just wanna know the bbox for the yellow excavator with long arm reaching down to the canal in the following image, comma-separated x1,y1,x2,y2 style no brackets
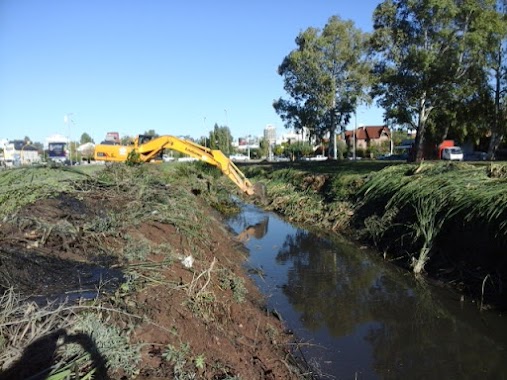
94,134,261,195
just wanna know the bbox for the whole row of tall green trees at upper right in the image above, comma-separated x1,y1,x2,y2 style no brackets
273,0,507,161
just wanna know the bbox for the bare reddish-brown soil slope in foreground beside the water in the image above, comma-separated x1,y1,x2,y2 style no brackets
130,223,302,379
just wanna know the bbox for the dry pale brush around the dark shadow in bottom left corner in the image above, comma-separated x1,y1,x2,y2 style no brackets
0,289,140,380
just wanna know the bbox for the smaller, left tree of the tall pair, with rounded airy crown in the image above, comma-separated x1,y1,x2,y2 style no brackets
273,16,370,159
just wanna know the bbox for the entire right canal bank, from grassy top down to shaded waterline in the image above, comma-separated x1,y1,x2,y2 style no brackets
247,162,507,308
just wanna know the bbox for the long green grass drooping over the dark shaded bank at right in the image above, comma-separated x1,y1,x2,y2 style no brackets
360,162,507,273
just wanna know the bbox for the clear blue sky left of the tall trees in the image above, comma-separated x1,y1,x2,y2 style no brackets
0,0,382,142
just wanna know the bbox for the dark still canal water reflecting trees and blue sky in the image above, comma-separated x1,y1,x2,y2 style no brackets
229,205,507,379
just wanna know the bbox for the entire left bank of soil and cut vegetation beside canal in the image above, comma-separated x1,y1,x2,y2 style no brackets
0,164,300,380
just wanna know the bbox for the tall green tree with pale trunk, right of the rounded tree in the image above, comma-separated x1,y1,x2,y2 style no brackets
372,0,498,161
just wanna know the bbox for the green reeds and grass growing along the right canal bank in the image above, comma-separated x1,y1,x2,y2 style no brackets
249,162,507,280
